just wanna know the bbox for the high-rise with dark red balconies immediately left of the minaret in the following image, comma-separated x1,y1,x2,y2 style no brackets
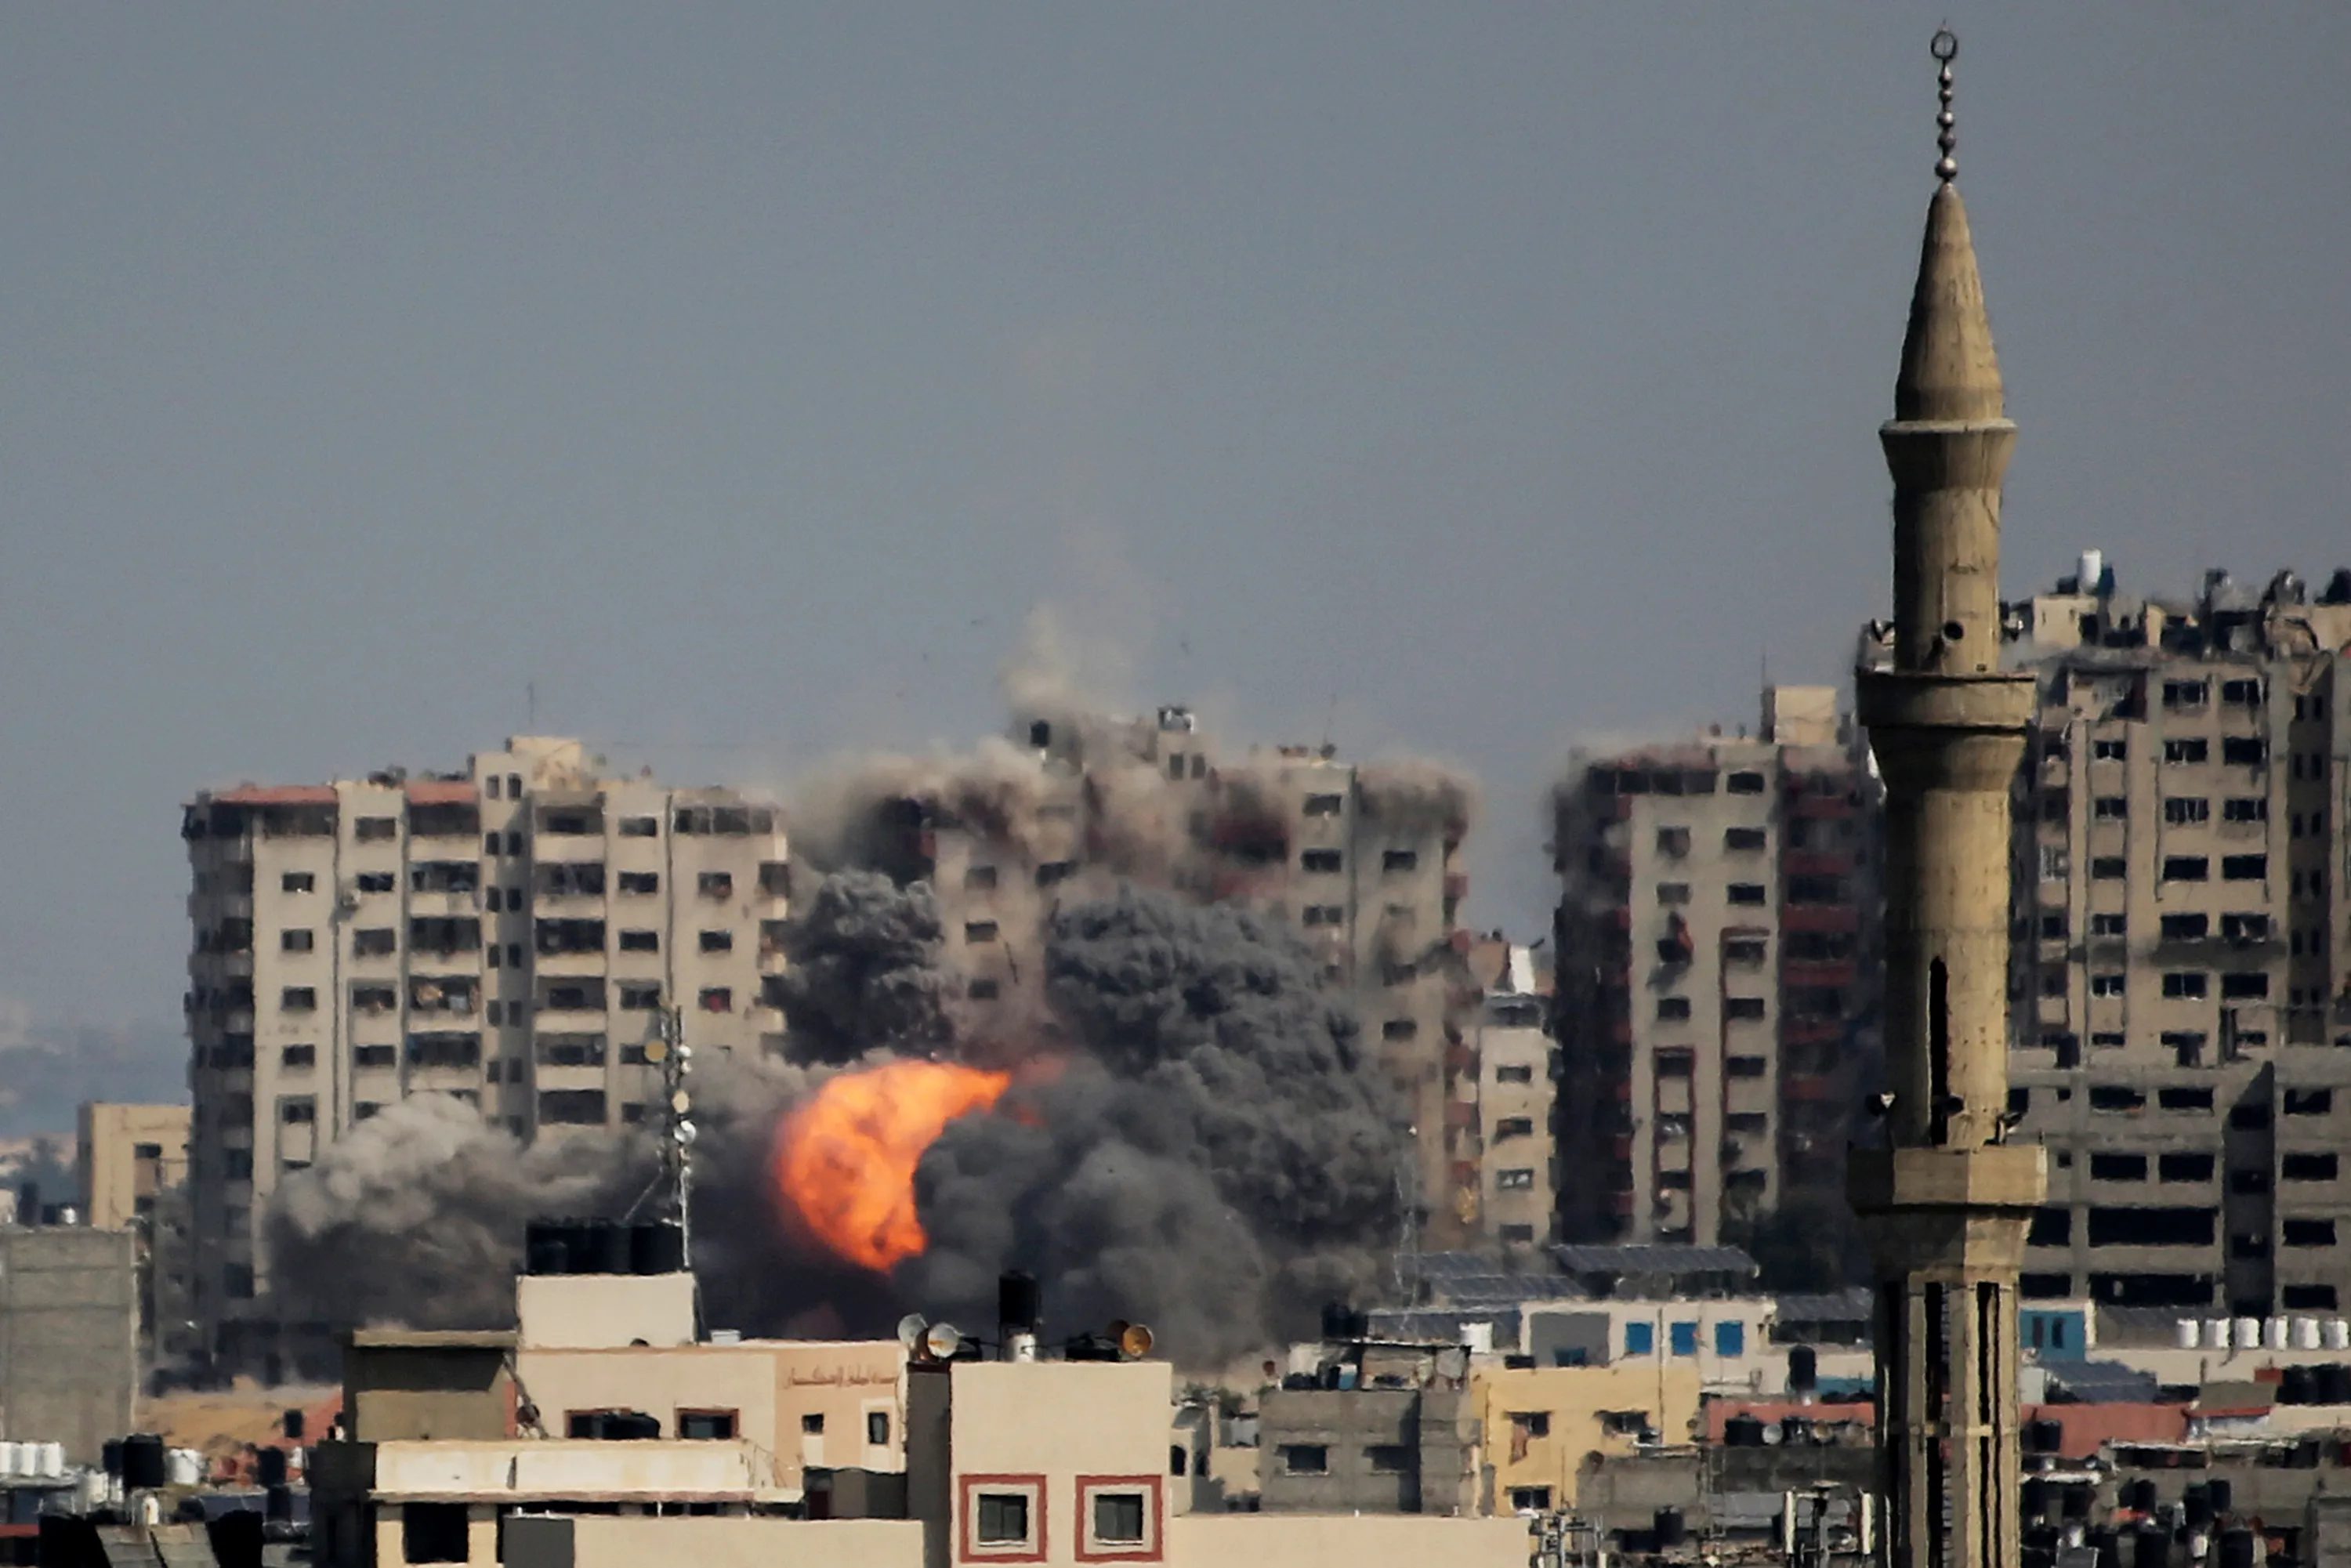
1552,686,1878,1246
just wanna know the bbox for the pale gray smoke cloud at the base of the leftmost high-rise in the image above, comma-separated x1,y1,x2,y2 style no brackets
268,1093,656,1328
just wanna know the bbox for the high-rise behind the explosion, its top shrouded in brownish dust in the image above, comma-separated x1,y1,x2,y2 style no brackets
856,708,1481,1248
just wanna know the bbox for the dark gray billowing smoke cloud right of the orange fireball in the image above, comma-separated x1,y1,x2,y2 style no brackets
900,889,1406,1366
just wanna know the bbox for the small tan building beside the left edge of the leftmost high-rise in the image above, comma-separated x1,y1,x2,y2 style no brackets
75,1100,195,1366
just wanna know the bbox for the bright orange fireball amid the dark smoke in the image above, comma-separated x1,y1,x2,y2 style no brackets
776,1060,1013,1274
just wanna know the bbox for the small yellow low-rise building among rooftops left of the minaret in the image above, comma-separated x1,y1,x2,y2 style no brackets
1469,1356,1700,1514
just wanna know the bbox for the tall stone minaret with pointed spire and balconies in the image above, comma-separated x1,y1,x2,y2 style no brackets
1848,33,2048,1568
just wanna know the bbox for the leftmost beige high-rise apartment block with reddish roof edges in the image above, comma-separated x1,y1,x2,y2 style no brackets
181,736,790,1363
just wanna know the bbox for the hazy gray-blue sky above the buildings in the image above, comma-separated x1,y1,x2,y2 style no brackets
0,0,2351,1063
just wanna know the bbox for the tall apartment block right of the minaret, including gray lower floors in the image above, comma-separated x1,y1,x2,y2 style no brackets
2008,552,2351,1314
